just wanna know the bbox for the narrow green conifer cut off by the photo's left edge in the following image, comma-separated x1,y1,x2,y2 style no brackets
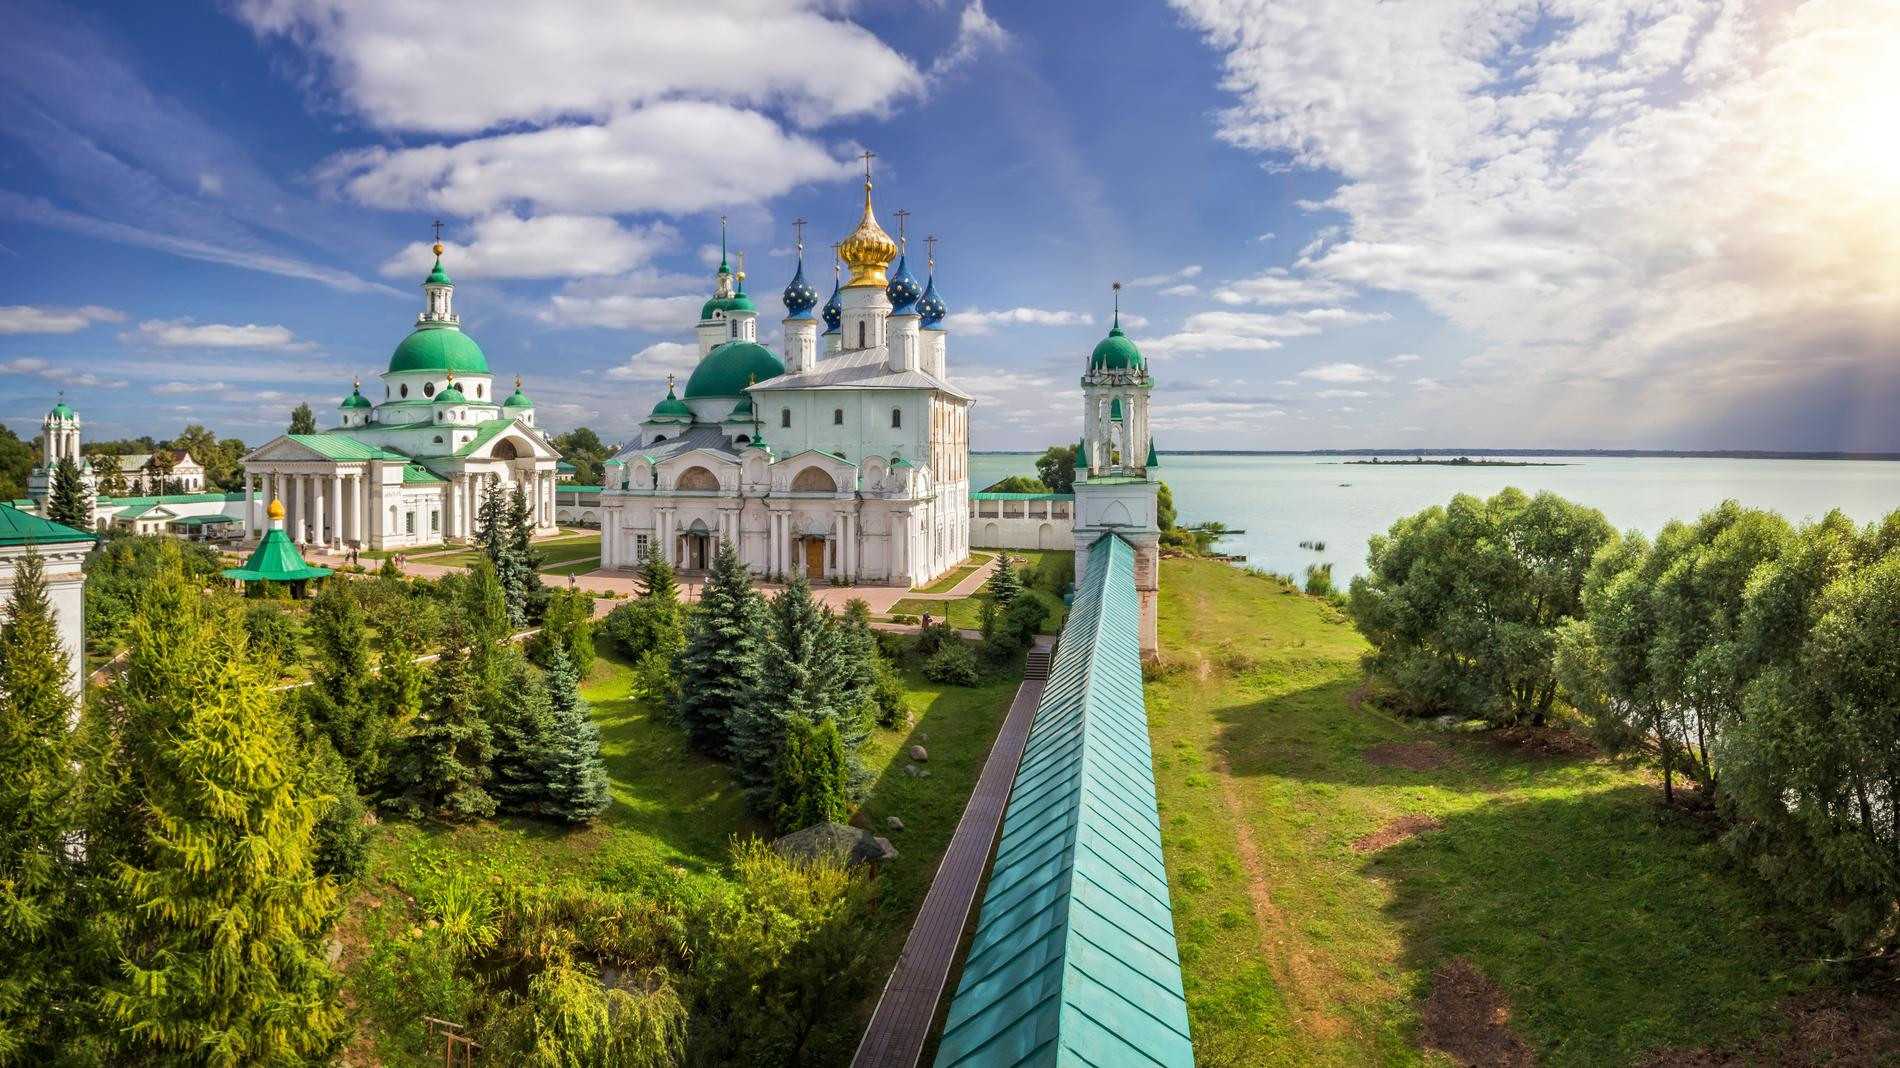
0,551,76,1064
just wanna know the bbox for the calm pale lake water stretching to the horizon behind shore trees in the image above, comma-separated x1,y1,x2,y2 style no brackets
969,452,1900,585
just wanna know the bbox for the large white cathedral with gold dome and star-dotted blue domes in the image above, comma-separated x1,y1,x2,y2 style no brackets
600,175,971,585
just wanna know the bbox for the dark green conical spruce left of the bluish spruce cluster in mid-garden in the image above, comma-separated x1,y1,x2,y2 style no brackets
410,620,496,819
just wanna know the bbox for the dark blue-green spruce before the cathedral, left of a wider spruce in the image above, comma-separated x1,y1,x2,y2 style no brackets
673,542,766,756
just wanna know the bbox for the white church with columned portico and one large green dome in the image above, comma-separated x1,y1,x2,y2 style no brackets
243,243,559,549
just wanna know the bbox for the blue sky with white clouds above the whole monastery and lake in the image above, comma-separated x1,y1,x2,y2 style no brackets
0,0,1900,450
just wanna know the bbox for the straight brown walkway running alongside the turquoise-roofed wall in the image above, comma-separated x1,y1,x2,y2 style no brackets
851,639,1049,1068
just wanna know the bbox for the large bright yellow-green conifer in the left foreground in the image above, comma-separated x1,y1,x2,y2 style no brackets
87,549,346,1064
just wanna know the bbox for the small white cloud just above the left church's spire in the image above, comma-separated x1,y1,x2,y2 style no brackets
382,213,678,277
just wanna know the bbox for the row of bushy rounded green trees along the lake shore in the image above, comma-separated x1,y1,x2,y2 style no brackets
1347,490,1900,952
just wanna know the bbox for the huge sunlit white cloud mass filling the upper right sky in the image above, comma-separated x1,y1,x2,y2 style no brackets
1174,0,1900,448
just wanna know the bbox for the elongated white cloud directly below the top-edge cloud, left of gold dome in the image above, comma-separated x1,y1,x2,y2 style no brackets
319,101,857,215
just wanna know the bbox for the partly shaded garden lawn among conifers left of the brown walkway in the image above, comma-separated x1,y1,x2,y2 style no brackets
342,630,1017,1066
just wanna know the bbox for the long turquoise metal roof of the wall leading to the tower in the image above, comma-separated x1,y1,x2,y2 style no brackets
937,534,1193,1068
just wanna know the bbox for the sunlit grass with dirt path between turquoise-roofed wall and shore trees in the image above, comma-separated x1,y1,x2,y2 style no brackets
1148,561,1813,1068
